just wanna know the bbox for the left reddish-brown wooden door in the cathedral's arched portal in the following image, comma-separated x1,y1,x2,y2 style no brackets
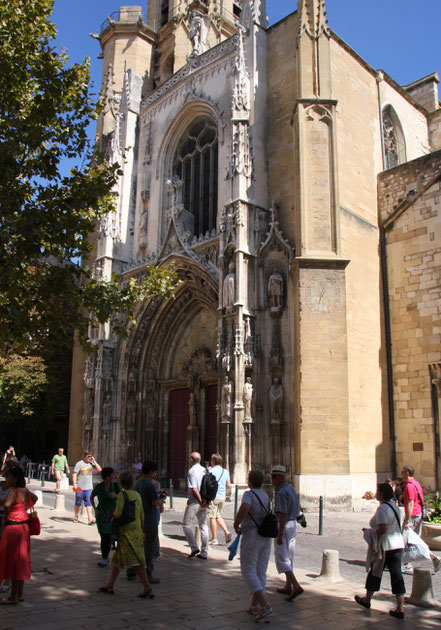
168,389,190,484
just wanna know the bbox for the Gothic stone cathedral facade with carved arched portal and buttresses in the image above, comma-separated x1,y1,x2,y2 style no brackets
69,0,441,504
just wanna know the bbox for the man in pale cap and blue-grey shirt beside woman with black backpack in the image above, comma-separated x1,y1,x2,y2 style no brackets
271,466,303,601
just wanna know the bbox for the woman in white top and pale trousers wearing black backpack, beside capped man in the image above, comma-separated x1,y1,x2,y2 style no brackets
234,470,273,621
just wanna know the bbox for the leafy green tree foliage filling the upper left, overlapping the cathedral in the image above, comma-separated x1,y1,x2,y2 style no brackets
0,0,174,352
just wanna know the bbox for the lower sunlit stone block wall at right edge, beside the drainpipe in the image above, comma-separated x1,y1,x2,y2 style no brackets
378,151,441,490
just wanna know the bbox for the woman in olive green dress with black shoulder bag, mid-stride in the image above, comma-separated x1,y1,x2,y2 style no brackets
100,470,154,599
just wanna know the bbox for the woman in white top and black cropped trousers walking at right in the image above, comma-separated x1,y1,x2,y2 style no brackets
355,483,406,619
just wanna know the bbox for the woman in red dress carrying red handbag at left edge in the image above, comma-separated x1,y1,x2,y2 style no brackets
0,464,38,606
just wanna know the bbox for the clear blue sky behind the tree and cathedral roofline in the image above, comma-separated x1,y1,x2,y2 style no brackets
53,0,441,95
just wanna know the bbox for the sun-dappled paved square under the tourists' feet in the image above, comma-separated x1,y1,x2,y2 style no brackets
0,484,441,630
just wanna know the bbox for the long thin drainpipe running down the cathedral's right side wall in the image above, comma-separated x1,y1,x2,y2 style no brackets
376,70,397,476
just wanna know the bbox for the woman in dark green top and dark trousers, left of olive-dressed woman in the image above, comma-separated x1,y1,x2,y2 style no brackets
90,466,121,567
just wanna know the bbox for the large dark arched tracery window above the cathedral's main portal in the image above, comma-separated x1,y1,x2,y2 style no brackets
173,116,218,236
